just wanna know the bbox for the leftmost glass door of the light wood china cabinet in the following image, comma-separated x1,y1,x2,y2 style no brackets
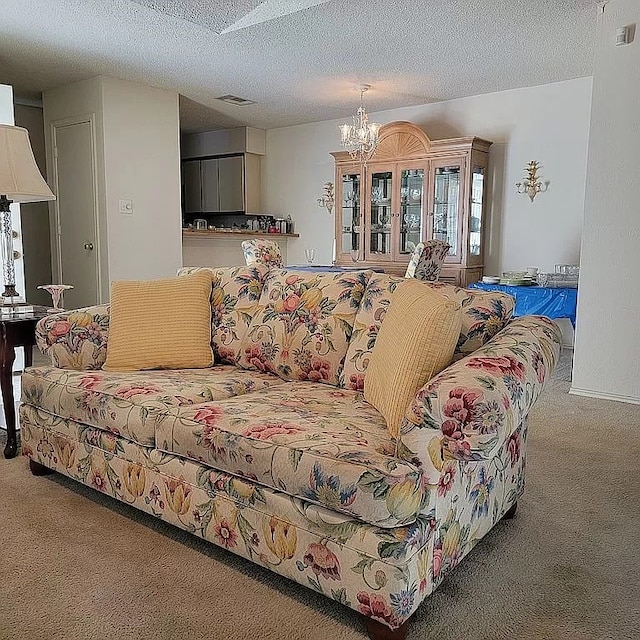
335,166,363,261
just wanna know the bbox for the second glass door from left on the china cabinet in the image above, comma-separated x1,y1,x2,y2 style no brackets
365,165,396,262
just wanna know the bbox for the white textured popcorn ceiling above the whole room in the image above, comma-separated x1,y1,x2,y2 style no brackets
0,0,599,130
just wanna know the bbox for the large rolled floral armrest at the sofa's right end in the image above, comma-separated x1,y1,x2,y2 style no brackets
398,316,560,469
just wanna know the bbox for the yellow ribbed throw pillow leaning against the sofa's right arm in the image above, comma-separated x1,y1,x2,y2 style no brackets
364,279,462,438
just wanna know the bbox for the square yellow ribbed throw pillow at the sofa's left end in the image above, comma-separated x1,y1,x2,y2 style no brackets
102,271,213,371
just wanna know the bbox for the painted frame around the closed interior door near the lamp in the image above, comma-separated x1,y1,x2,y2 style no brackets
49,113,103,304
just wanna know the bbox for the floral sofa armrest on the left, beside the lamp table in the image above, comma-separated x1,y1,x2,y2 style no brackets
36,305,109,371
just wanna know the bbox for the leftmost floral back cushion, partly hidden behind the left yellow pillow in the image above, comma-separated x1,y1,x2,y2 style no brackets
178,264,269,364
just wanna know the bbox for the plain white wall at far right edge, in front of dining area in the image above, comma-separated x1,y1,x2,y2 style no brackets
572,0,640,403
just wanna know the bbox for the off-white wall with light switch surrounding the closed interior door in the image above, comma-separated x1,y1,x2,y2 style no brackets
43,76,182,301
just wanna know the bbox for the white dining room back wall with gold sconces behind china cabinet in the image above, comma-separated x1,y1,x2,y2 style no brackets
263,78,591,274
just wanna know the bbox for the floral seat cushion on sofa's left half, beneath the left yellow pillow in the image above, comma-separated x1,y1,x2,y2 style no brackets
22,366,283,447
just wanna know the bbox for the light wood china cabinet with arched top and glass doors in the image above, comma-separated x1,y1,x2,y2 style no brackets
331,122,491,286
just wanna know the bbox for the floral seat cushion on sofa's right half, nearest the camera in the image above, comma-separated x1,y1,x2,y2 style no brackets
156,382,428,527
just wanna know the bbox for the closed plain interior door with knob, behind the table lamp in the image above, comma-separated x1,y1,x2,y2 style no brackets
52,120,99,309
